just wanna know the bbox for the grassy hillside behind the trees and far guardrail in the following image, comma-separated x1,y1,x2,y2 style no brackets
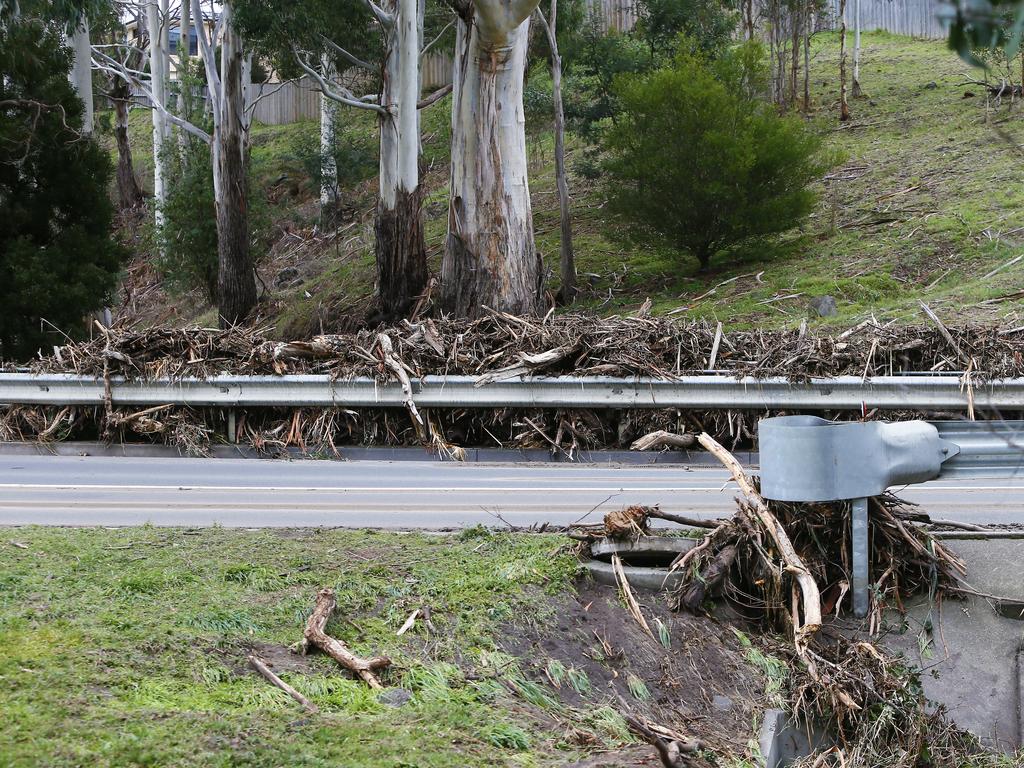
108,33,1024,336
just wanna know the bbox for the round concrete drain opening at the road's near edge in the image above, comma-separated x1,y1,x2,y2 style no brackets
586,536,698,592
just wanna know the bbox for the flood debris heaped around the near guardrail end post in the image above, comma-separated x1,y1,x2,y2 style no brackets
585,434,1005,768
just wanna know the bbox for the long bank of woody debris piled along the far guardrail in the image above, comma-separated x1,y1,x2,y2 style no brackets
0,311,1024,458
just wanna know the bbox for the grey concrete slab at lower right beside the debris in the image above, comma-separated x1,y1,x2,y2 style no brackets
883,540,1024,750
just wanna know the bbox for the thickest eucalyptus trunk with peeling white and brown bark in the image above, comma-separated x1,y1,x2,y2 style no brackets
441,0,541,316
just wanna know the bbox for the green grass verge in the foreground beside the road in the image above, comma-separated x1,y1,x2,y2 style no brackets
0,527,598,768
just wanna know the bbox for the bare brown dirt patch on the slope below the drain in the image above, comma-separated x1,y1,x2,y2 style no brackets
505,579,765,753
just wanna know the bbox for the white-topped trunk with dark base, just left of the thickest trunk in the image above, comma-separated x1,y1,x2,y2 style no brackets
376,0,427,315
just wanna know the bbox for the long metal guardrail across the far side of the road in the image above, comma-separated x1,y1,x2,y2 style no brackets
0,374,1024,412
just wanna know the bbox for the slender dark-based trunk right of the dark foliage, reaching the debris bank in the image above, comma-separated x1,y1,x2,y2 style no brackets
213,9,256,327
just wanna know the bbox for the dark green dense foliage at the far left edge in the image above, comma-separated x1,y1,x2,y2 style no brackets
0,17,124,357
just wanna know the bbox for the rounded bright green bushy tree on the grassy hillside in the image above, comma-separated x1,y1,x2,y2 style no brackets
604,43,827,270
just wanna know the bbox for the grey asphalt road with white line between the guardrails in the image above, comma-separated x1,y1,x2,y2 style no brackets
0,456,1024,528
